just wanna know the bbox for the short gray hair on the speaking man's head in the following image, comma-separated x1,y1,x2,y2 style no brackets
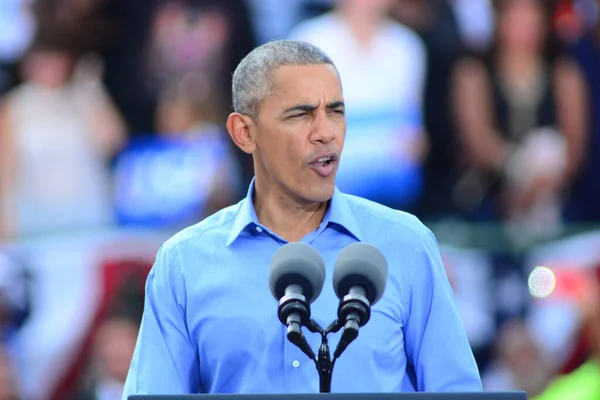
232,40,335,117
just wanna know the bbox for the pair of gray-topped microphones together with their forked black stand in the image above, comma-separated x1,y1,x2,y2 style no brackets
269,242,388,393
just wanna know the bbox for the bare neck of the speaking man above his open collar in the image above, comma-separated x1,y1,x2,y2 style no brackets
252,177,328,242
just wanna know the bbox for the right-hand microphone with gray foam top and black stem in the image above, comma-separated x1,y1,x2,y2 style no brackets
333,243,388,360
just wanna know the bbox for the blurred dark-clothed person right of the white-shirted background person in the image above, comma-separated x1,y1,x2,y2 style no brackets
392,0,465,221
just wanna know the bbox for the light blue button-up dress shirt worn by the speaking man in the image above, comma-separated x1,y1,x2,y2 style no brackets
123,184,481,399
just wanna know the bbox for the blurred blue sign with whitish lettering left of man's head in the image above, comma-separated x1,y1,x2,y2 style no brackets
115,128,238,226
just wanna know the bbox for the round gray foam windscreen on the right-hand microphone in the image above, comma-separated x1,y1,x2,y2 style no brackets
333,243,388,305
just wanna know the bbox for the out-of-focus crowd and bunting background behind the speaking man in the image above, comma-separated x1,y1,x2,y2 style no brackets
0,0,600,400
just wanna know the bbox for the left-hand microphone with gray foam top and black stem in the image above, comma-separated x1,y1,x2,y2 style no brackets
269,242,325,360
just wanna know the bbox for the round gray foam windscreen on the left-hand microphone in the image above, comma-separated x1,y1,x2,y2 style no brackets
269,242,325,304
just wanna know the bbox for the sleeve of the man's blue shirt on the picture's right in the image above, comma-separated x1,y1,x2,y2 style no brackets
405,229,482,392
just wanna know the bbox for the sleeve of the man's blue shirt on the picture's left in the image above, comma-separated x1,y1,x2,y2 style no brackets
122,242,200,400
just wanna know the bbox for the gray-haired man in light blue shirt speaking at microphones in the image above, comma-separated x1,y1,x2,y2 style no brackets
123,41,481,399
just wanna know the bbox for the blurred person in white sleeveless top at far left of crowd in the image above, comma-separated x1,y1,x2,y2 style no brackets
0,24,125,239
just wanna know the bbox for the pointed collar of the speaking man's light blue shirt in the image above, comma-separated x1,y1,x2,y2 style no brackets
225,178,363,246
